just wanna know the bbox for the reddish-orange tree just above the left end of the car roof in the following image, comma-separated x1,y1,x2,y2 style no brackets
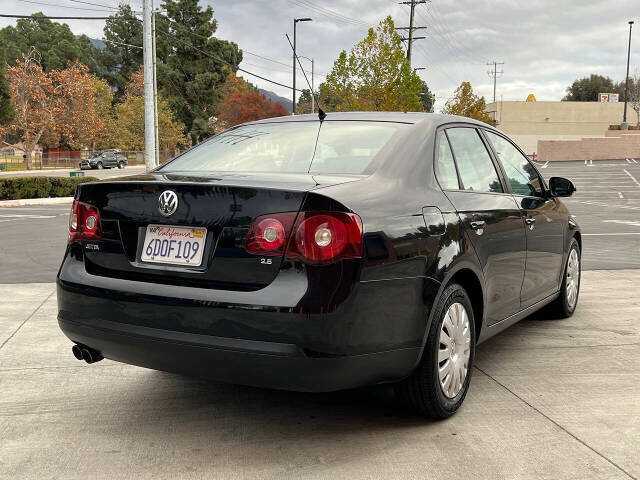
216,92,288,130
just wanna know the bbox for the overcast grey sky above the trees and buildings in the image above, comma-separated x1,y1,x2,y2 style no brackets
0,0,640,110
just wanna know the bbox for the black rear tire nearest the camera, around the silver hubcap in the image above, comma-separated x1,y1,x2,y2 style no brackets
395,283,476,419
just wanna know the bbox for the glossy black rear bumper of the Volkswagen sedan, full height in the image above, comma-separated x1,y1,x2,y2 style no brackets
58,254,439,391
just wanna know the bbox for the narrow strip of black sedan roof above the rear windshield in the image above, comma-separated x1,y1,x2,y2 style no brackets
246,112,490,127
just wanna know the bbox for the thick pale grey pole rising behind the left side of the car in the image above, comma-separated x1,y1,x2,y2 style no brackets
142,0,156,171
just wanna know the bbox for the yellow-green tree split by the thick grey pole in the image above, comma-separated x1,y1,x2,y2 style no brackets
105,68,186,150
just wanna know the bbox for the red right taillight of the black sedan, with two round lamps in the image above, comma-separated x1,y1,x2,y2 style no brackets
246,212,362,264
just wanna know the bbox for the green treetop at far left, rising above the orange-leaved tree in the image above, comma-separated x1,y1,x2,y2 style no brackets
0,13,100,72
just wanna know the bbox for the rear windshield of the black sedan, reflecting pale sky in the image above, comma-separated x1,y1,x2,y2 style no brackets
160,121,406,174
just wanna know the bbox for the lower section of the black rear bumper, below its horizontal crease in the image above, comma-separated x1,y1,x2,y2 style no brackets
58,318,420,392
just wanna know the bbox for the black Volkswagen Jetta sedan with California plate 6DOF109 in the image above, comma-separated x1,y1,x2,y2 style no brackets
57,113,582,418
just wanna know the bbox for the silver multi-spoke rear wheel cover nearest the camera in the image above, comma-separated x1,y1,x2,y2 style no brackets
438,303,471,398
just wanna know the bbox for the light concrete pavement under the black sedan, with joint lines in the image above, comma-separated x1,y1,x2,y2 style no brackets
0,270,640,480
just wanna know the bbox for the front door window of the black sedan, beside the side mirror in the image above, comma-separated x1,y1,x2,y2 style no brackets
485,131,543,197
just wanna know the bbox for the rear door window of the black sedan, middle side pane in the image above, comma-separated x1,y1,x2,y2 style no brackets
447,127,503,193
